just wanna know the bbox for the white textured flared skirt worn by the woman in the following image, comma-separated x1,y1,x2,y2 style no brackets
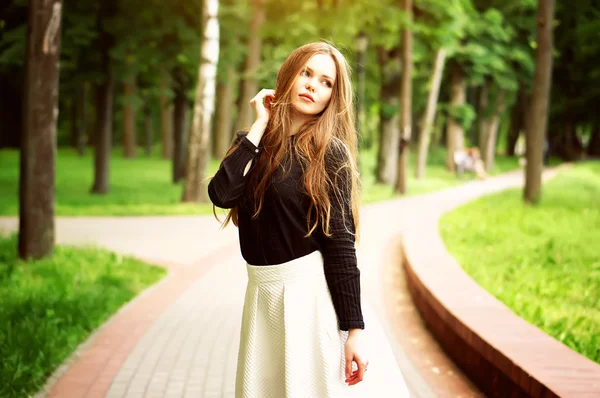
235,251,409,398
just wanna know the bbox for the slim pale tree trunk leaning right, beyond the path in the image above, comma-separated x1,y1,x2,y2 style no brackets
415,48,446,179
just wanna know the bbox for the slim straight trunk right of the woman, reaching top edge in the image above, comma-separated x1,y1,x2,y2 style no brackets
396,0,413,194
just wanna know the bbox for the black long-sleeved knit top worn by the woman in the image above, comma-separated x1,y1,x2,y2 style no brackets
208,132,364,330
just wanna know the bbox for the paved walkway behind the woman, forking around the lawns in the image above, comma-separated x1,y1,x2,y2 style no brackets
0,166,564,398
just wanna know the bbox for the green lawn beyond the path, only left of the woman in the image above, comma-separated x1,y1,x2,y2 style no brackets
0,148,223,216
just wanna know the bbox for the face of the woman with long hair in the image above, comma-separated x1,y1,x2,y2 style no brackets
291,54,336,116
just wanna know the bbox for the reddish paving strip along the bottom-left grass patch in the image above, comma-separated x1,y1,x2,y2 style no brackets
39,242,238,398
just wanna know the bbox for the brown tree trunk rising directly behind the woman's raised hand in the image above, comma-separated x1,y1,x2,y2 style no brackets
236,0,265,130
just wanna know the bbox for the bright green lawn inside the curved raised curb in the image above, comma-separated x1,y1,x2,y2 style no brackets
440,162,600,363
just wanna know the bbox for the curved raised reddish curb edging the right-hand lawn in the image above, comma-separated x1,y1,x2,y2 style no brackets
403,211,600,398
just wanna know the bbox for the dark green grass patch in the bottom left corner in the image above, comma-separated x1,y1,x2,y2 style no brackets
0,235,165,398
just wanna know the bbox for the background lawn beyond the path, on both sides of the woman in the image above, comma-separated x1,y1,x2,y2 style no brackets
0,148,518,216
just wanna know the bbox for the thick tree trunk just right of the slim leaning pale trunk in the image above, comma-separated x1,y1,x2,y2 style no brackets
446,64,466,172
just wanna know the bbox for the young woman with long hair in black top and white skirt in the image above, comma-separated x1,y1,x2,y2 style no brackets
208,42,408,398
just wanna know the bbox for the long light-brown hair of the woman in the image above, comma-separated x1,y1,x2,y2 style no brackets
213,42,359,240
